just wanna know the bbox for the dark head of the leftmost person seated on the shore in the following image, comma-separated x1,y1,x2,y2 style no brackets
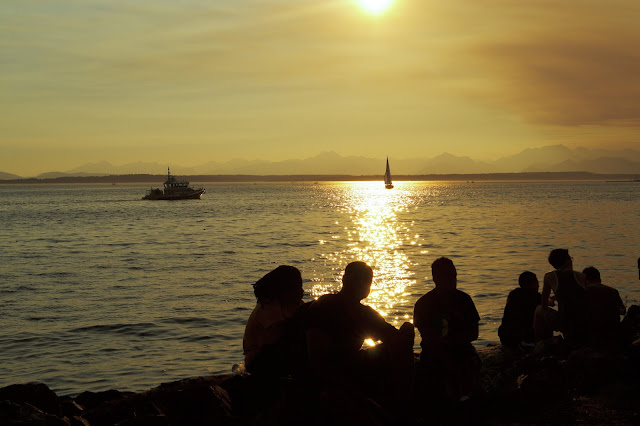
253,265,304,307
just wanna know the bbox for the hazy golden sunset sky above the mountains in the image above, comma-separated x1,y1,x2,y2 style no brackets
0,0,640,176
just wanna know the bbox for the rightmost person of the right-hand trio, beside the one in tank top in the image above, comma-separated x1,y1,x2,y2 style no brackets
582,266,627,347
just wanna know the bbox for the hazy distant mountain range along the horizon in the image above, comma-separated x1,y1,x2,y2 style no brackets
5,145,640,180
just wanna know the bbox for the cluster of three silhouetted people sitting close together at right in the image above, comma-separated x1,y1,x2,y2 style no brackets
498,249,626,351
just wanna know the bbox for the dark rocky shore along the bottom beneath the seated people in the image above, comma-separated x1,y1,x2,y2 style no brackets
5,306,640,426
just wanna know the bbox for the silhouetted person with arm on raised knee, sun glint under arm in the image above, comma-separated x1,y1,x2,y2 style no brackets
306,262,414,410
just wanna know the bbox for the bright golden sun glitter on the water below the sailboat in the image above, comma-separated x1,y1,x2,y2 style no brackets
312,182,420,325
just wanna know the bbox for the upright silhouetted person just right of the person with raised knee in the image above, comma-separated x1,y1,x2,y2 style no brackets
413,257,480,412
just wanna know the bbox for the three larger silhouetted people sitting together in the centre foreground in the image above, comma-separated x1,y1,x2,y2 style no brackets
243,257,480,422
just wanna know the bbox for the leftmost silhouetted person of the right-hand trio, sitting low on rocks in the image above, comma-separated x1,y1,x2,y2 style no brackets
498,271,542,350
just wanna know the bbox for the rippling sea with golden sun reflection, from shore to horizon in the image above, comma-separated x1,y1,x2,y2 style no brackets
0,182,640,395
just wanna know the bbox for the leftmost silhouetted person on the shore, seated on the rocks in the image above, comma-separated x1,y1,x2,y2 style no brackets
242,265,306,376
